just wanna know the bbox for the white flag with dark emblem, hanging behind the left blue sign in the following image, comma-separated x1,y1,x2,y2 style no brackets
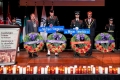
40,6,47,41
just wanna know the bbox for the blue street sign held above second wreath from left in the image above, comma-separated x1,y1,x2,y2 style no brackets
38,26,64,33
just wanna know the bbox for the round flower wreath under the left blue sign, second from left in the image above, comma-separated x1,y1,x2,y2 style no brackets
46,32,67,53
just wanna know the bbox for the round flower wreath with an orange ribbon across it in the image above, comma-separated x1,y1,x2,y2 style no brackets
71,34,91,54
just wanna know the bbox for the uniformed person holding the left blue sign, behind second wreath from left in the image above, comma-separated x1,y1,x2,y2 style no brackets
46,10,60,56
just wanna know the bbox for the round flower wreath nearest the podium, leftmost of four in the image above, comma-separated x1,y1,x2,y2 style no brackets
24,33,44,53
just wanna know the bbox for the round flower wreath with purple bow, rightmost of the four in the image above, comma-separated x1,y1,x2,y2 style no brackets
95,33,115,52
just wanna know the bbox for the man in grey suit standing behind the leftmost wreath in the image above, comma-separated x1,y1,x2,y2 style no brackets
25,13,38,58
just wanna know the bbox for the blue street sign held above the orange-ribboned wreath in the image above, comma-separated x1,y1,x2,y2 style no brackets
64,29,90,34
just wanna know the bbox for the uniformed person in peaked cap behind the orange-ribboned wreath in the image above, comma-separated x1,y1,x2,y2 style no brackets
70,11,83,57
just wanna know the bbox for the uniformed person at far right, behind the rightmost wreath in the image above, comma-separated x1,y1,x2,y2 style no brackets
105,18,115,52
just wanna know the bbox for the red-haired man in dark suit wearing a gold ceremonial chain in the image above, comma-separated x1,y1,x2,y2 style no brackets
85,11,96,56
